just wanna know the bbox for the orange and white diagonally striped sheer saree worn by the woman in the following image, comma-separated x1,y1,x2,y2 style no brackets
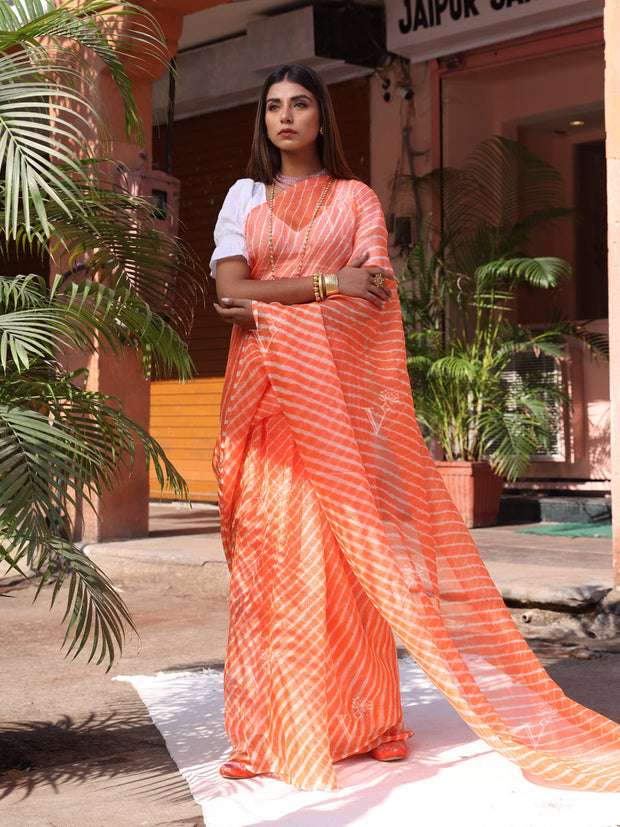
215,177,620,791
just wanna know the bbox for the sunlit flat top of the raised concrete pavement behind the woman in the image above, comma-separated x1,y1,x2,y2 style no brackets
85,503,613,600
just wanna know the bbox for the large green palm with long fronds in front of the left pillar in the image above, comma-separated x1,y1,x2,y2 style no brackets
0,0,204,665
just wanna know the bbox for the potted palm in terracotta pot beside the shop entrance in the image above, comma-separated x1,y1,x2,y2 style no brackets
400,137,606,527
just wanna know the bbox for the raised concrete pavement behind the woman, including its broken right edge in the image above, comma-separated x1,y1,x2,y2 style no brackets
86,503,620,640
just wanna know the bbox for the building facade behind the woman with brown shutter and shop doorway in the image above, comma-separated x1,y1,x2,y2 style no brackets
145,0,611,500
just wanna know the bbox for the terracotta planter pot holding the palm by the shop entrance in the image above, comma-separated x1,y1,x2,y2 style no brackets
437,462,504,528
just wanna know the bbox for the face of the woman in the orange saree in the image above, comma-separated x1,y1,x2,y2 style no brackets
265,80,321,159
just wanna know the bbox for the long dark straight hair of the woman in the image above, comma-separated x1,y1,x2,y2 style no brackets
246,63,357,184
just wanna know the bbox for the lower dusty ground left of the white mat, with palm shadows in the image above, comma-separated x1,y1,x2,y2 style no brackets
0,585,227,827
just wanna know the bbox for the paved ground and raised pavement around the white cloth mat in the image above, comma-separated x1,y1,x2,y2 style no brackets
0,506,620,827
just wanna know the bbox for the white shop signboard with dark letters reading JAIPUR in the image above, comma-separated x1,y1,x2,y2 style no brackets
385,0,604,63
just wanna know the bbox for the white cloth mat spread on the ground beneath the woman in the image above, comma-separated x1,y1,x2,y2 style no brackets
117,658,620,827
